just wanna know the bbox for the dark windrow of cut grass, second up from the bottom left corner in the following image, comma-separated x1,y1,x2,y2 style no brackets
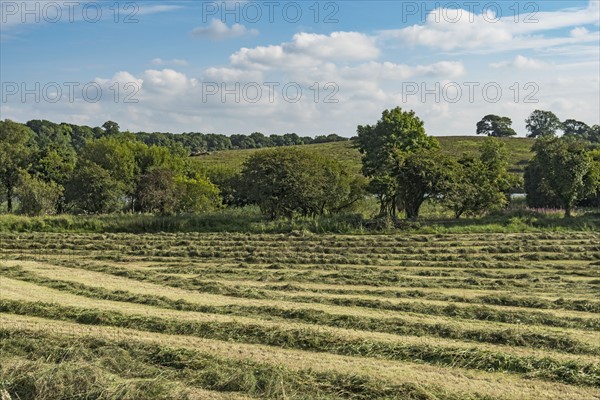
0,300,600,388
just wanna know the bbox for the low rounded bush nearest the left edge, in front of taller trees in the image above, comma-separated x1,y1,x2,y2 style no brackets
15,172,63,216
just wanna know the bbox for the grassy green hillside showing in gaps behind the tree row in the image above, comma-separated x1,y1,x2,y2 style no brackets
195,136,533,172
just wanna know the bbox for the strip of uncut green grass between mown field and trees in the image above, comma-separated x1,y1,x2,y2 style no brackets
0,205,600,235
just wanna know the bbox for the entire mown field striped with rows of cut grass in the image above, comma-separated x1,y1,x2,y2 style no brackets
0,231,600,400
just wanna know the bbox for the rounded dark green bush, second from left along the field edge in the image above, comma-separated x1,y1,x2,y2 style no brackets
65,159,125,214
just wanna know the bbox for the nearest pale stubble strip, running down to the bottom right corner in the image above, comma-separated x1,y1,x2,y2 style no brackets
0,314,597,400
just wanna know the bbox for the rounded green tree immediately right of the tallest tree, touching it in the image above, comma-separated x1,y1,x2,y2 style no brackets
394,149,454,220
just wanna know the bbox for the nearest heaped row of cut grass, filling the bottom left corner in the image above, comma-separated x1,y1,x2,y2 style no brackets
0,330,486,400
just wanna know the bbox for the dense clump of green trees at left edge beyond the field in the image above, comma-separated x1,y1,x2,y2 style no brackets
0,120,221,215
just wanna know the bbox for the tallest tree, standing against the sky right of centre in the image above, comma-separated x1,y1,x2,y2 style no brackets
356,107,439,217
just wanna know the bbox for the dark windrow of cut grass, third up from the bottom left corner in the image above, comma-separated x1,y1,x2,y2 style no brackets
0,267,600,355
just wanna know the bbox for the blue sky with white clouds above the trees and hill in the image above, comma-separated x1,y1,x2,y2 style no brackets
0,0,600,137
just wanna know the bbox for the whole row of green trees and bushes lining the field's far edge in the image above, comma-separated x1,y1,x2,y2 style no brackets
0,107,600,219
